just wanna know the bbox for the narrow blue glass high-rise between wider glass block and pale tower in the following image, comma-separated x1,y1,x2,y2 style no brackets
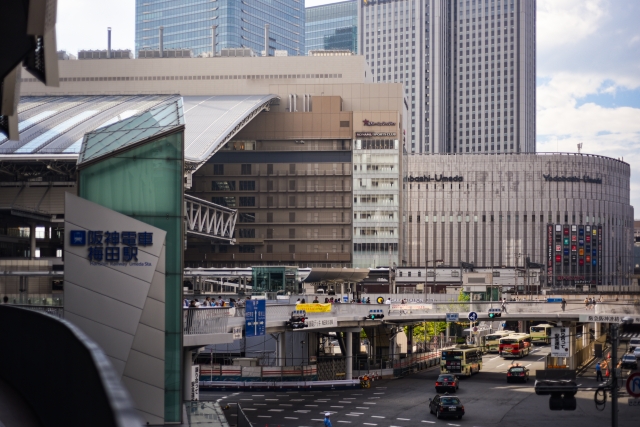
305,0,358,55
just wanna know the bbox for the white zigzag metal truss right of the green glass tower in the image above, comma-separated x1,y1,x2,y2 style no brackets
184,194,238,244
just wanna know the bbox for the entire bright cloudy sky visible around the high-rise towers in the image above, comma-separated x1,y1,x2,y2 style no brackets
57,0,640,214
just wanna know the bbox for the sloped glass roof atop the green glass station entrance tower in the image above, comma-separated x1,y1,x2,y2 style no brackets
78,97,184,165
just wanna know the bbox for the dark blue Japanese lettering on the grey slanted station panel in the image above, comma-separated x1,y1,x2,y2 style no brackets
69,230,153,267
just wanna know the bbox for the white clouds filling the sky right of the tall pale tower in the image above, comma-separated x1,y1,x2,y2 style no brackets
537,0,640,216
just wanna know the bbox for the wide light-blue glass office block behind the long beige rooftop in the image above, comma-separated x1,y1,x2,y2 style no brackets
136,0,305,56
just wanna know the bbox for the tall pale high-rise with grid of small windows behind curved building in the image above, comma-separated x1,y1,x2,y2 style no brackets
358,0,536,154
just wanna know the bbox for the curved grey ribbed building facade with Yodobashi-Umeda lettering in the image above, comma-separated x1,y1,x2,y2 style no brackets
403,153,633,290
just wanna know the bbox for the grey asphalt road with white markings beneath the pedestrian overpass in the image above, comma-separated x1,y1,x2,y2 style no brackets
205,346,640,427
